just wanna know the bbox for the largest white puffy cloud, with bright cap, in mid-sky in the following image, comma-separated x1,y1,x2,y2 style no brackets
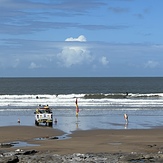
57,35,93,67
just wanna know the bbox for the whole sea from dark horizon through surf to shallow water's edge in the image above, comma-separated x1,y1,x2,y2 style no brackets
0,77,163,133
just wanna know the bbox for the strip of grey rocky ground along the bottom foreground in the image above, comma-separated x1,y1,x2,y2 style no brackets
0,149,163,163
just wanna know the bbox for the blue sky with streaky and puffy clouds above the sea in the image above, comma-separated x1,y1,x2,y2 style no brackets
0,0,163,77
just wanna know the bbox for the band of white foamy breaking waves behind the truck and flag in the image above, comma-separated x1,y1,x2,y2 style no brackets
0,93,163,111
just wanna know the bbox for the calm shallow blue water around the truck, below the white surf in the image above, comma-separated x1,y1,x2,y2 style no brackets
0,109,163,133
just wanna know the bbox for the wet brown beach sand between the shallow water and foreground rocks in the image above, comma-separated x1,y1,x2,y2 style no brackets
0,126,163,155
